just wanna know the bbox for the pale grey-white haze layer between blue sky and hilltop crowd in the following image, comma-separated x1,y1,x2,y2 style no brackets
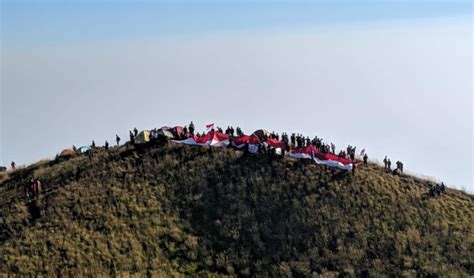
0,3,474,191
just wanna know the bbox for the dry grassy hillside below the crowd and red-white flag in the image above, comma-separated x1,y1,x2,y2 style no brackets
0,145,474,276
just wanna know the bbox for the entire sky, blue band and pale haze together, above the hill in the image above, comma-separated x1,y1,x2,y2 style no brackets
0,1,474,191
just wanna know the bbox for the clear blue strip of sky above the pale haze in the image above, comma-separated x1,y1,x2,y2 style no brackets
2,0,472,47
